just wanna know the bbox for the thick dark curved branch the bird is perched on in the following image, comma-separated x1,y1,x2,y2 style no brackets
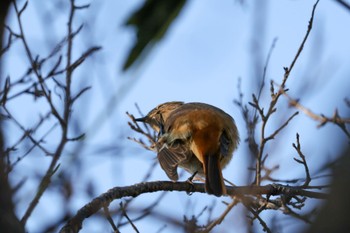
60,181,328,233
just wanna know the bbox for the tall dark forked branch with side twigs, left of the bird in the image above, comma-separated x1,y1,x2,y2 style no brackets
11,0,101,225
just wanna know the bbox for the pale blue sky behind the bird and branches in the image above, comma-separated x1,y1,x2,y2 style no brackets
3,0,350,232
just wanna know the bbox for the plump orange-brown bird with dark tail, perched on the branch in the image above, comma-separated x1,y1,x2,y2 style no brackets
136,101,240,196
